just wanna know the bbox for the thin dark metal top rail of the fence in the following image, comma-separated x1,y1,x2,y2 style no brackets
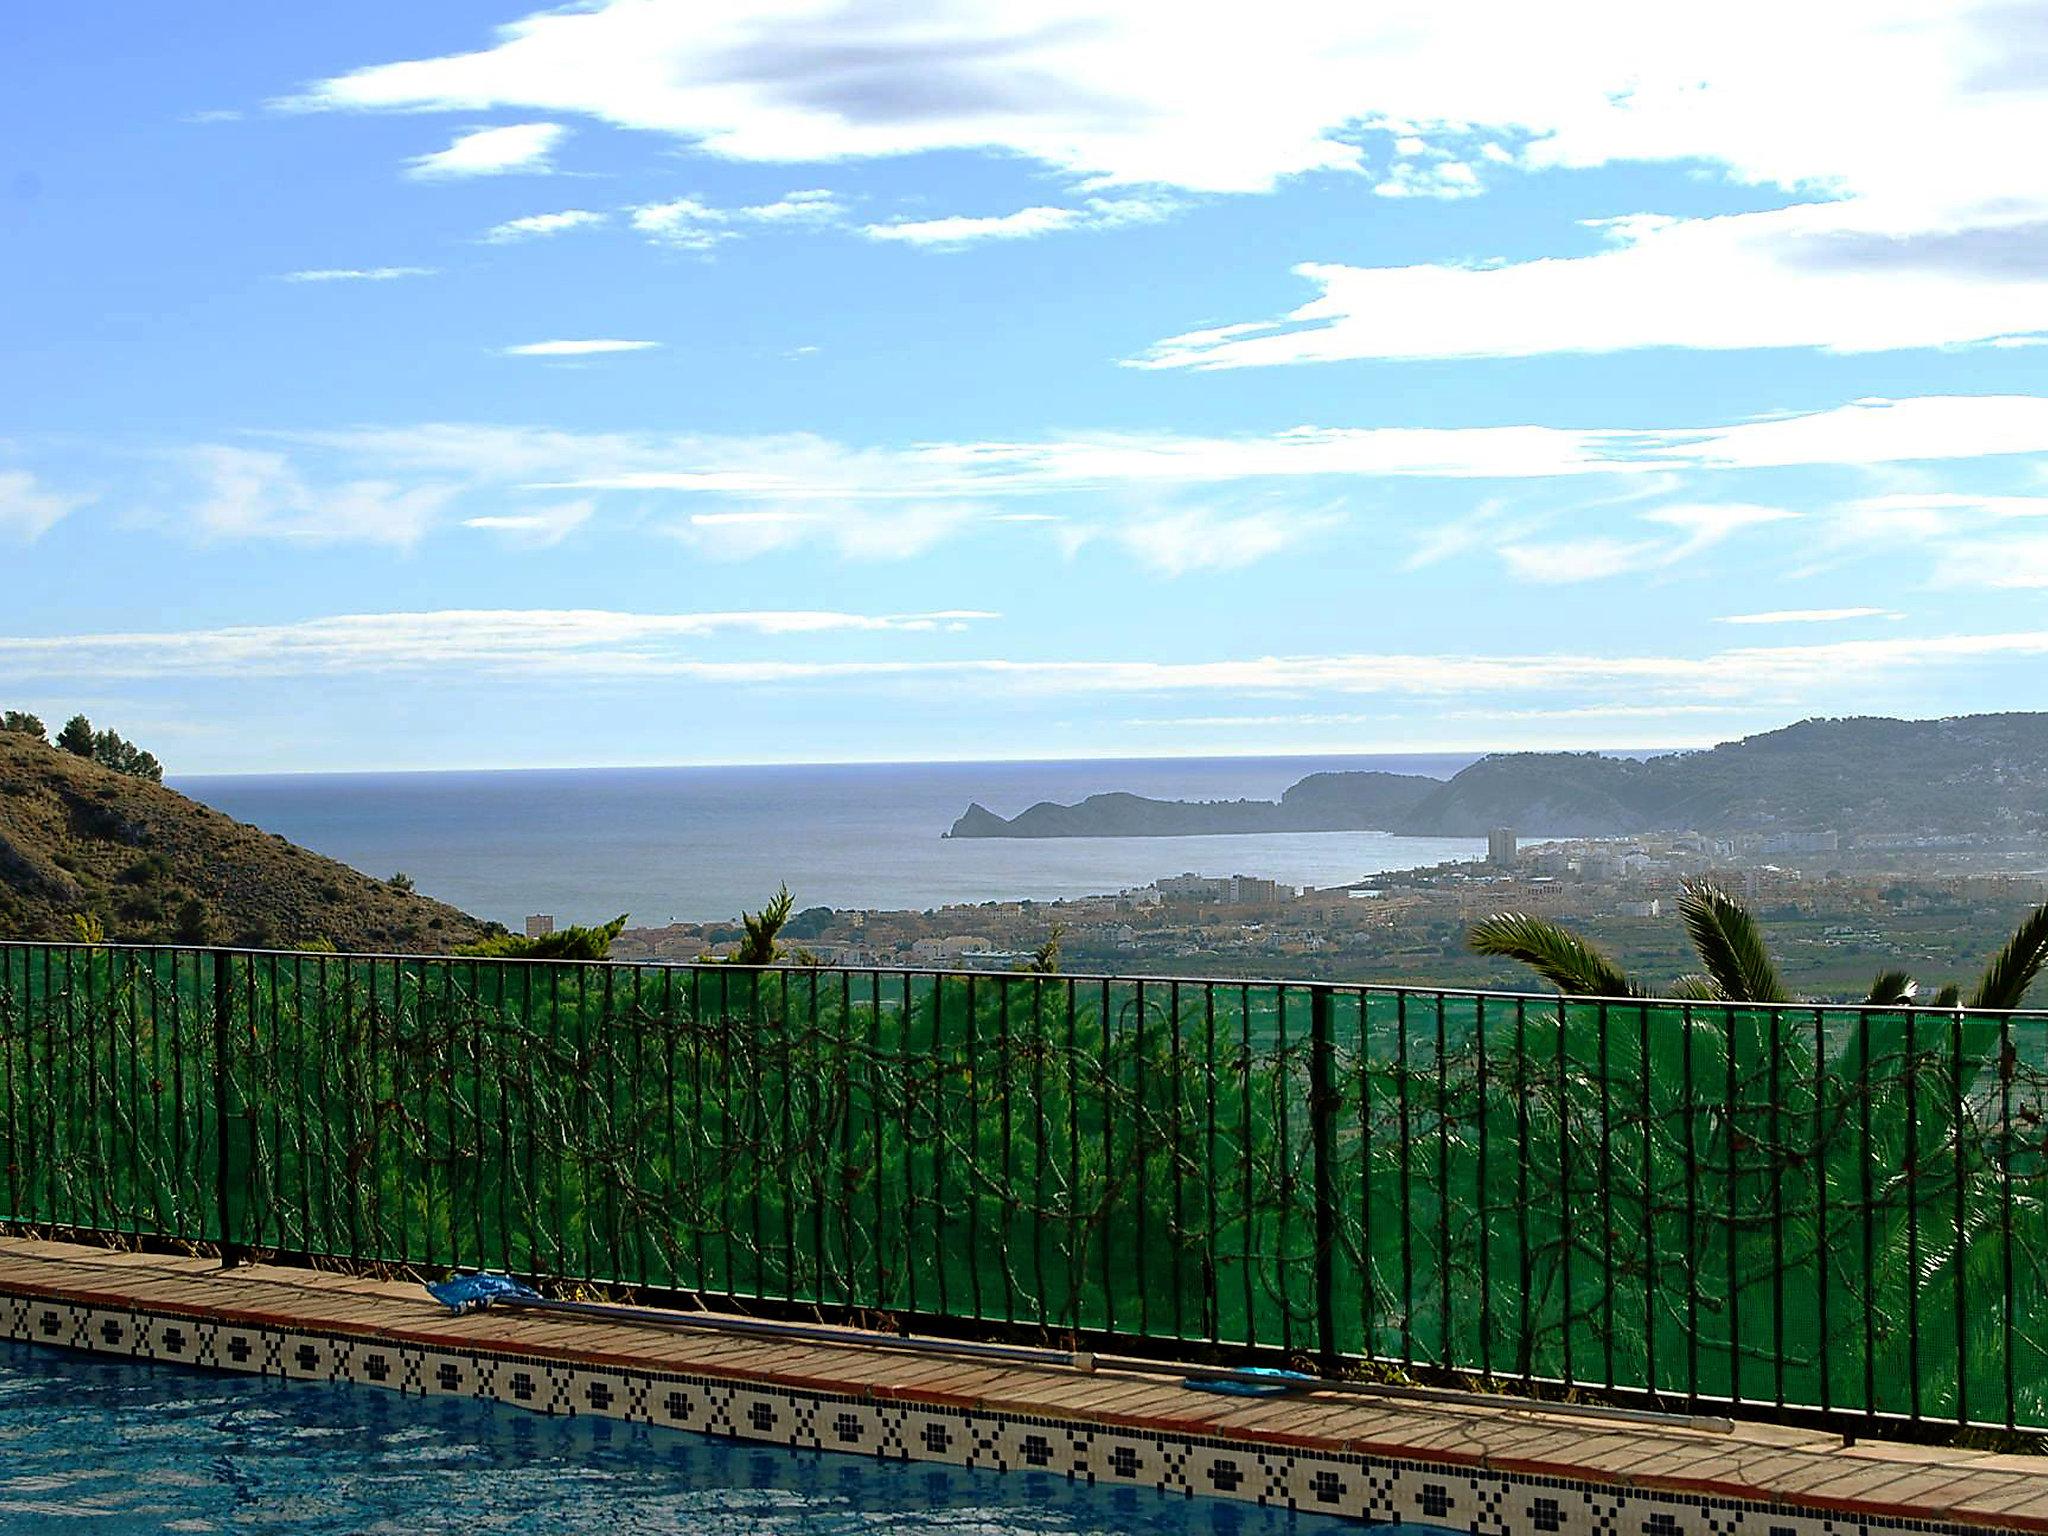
0,938,2048,1020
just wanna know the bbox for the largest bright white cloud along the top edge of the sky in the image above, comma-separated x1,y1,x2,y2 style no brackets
303,0,2042,197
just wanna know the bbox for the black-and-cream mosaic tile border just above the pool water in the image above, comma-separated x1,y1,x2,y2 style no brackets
0,1294,2015,1536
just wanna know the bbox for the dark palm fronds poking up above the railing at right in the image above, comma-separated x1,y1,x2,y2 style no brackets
1466,879,2048,1010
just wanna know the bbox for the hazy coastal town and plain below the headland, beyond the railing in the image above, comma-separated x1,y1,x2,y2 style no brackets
612,827,2048,993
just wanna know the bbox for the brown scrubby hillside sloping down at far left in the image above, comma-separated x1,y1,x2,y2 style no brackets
0,731,483,952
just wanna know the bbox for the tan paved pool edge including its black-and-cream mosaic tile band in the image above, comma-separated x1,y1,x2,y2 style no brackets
0,1239,2048,1536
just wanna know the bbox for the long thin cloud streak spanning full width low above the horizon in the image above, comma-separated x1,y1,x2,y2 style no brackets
12,610,2048,713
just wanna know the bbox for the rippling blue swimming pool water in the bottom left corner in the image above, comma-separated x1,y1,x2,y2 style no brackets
0,1343,1401,1536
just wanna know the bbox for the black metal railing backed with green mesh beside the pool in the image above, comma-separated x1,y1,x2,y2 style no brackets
0,944,2048,1430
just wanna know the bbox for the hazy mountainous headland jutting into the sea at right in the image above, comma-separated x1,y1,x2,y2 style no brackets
948,713,2048,838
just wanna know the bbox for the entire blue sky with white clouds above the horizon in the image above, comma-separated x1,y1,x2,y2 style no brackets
0,0,2048,776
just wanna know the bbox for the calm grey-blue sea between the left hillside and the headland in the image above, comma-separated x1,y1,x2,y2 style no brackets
170,754,1485,928
